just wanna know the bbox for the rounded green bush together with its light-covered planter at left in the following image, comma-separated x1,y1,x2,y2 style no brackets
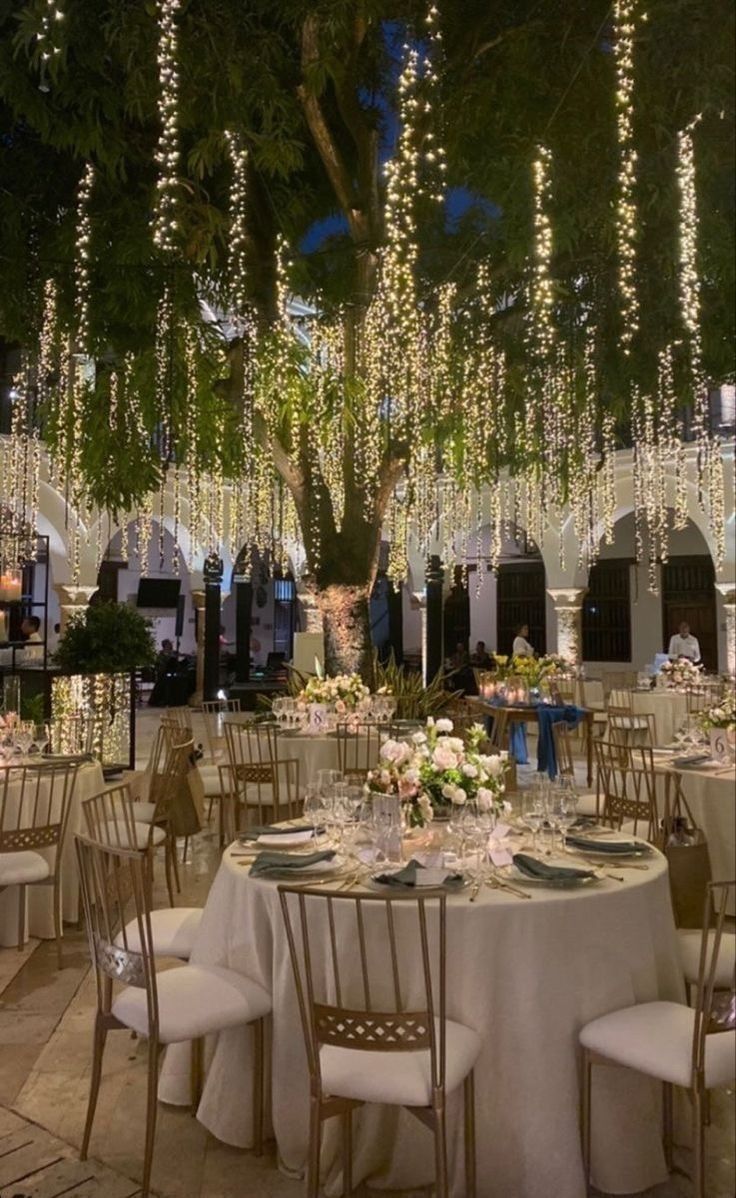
52,603,156,768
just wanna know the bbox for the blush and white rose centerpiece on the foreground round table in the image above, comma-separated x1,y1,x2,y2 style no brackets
368,718,509,828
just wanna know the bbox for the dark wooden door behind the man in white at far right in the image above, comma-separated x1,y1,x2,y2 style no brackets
662,553,718,670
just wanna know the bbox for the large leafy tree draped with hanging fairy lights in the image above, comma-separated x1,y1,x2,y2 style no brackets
0,0,734,670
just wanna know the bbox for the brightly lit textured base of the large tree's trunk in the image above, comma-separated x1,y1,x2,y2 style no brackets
313,583,373,686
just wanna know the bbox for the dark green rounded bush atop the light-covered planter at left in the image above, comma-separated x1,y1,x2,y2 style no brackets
54,603,156,673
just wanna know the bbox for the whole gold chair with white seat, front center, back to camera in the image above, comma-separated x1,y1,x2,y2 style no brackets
278,885,481,1198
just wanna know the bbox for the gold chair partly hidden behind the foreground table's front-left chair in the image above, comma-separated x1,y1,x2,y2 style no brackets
82,785,201,961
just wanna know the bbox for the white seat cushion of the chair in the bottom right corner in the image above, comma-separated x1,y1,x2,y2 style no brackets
580,1003,736,1089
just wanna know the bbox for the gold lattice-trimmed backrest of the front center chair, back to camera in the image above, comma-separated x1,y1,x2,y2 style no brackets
278,885,446,1089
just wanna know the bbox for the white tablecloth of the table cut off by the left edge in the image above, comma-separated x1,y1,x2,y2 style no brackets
0,761,105,946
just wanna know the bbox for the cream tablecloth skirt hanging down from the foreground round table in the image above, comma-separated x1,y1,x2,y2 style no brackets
159,846,684,1198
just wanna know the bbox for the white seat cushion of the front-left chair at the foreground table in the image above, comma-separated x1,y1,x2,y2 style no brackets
113,966,271,1045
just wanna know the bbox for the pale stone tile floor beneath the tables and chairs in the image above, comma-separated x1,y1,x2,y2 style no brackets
0,710,735,1198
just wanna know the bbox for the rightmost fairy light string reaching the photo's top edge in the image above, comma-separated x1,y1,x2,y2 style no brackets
614,0,639,353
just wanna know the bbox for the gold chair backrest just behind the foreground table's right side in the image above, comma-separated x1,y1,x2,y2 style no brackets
593,740,657,843
